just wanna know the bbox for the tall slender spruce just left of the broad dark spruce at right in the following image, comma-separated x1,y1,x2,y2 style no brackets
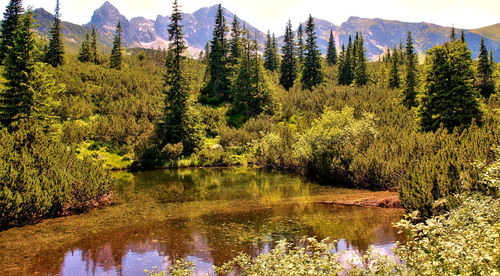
403,31,418,108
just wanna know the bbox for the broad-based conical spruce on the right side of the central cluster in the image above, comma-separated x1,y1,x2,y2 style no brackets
234,33,272,115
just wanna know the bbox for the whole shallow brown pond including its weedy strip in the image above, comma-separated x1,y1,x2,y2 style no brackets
0,168,402,275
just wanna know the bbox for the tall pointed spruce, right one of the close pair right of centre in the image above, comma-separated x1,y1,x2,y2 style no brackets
302,15,324,90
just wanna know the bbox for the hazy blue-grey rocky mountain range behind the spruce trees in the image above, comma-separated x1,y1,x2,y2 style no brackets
35,2,500,62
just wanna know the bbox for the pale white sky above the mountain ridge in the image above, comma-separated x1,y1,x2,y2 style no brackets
0,0,500,33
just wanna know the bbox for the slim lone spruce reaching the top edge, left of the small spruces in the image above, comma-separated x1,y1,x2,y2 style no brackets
45,0,64,67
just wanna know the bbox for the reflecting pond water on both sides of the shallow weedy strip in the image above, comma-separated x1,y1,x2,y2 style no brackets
1,169,401,275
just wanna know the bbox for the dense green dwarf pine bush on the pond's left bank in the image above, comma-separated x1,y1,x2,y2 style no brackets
0,121,112,227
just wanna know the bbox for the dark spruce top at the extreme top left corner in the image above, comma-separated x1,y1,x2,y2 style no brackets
0,0,24,64
